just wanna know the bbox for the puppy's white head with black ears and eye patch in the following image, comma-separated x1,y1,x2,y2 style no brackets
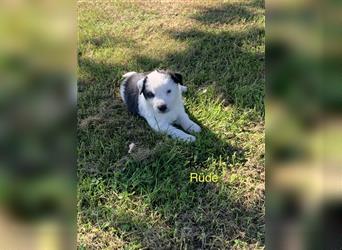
138,70,185,113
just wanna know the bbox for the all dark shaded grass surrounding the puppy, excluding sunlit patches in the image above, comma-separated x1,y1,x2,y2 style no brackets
78,2,264,249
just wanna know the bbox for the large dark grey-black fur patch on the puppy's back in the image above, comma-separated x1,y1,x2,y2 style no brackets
124,73,146,115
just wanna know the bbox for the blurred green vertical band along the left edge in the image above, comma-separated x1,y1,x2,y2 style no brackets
0,0,77,250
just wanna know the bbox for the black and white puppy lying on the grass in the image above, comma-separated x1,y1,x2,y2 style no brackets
120,70,201,142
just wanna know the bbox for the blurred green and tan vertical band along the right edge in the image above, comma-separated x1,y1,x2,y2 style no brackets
266,0,342,250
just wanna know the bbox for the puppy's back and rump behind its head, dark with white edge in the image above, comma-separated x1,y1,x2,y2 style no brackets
120,72,145,115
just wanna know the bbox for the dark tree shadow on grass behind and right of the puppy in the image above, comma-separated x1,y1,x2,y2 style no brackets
166,29,264,112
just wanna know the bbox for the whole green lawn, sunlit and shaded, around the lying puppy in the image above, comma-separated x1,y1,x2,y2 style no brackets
78,0,265,249
